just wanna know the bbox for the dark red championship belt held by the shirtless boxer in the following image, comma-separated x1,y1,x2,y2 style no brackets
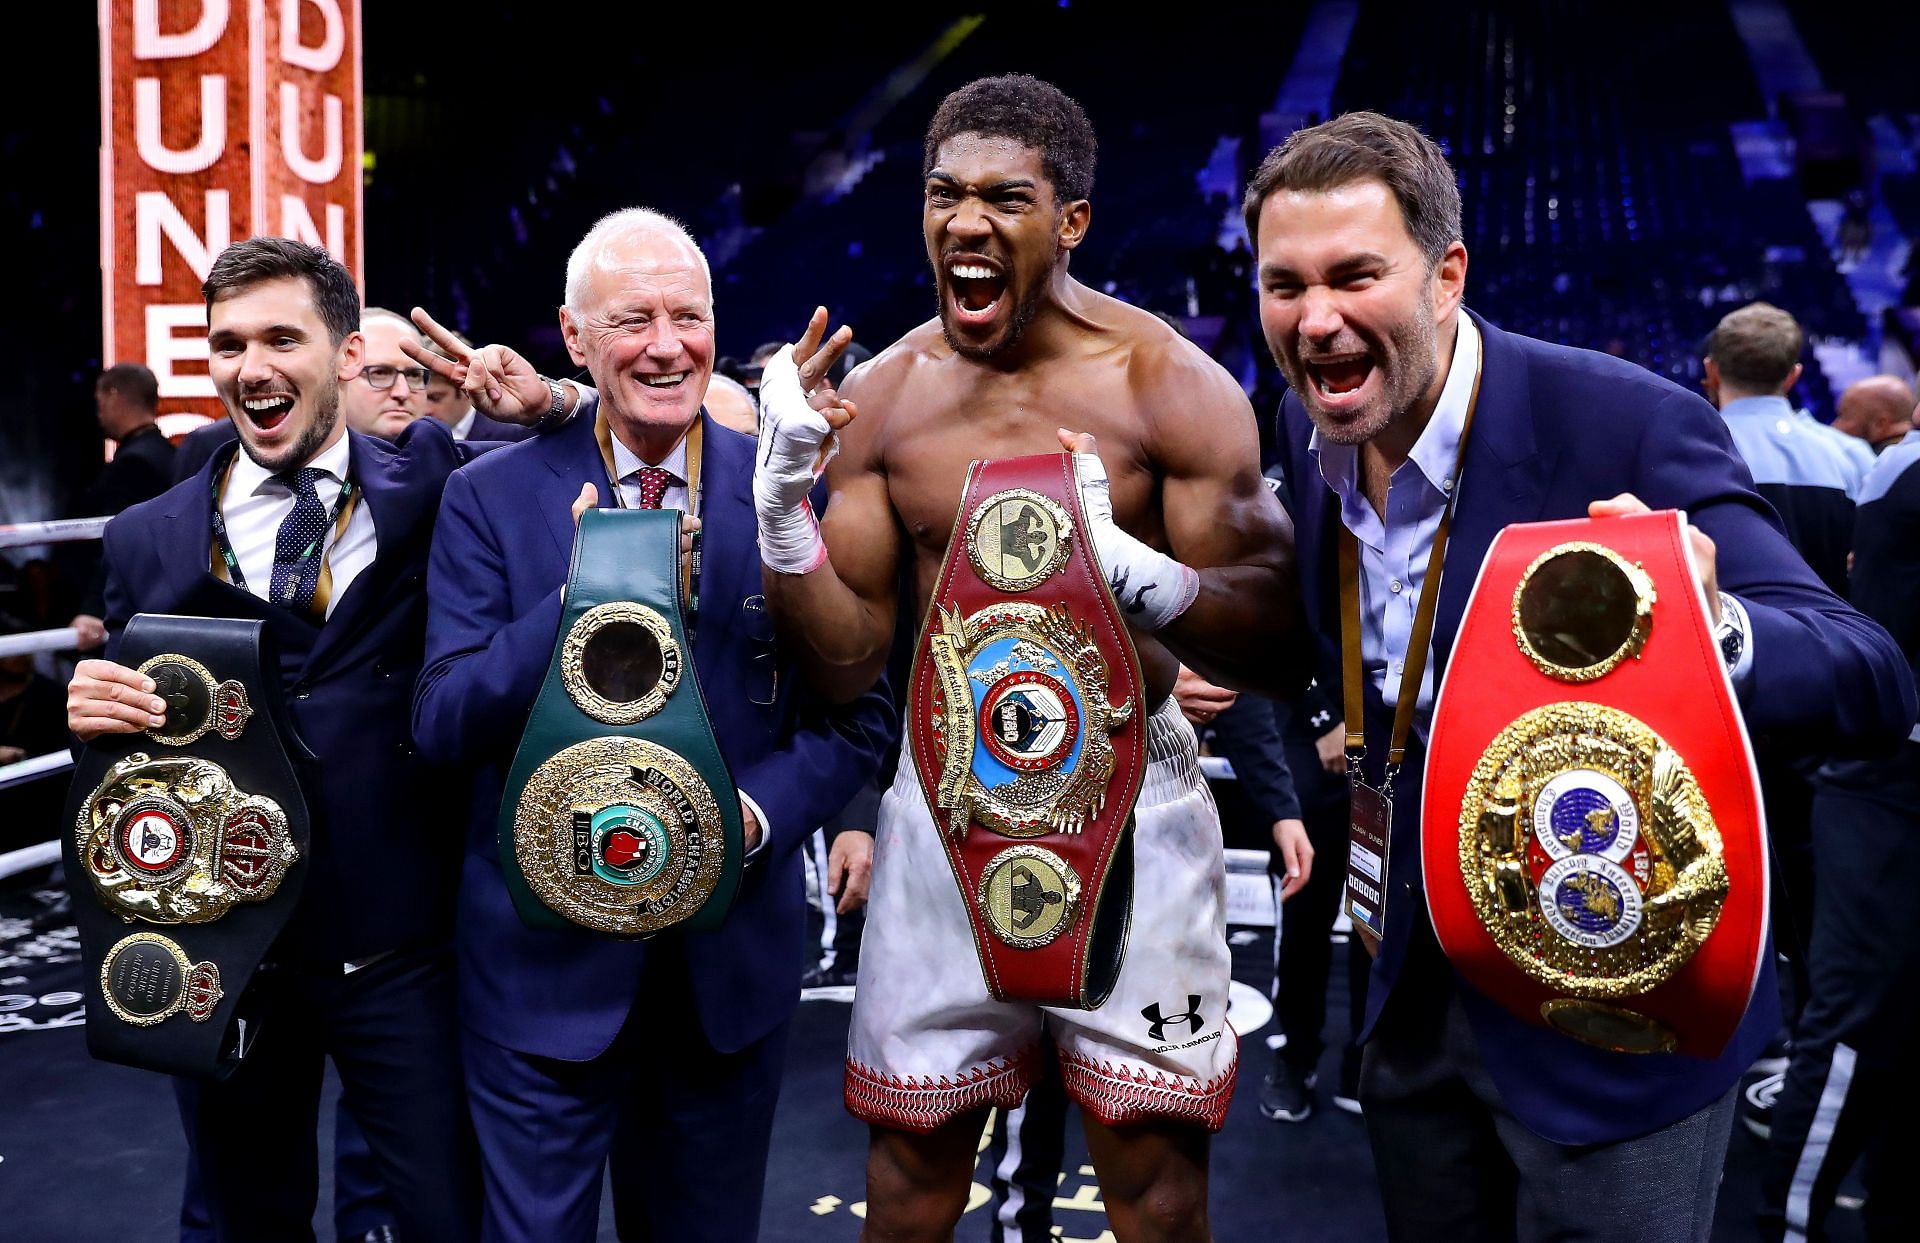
906,453,1146,1009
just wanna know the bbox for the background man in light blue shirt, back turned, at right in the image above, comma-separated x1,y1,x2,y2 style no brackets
1705,302,1859,596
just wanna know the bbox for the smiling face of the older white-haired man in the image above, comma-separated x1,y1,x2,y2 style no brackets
561,231,714,453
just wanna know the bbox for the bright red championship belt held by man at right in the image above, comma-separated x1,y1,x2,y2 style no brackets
1421,511,1766,1057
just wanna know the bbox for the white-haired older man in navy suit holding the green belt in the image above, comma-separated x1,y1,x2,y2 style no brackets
413,209,893,1243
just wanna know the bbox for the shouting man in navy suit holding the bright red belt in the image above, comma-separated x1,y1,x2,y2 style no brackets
1246,113,1914,1243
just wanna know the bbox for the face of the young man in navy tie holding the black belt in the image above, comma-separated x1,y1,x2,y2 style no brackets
207,277,361,473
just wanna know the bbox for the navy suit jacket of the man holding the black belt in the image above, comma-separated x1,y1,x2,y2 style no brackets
106,419,483,964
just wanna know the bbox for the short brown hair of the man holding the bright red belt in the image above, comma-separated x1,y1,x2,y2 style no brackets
1242,111,1461,269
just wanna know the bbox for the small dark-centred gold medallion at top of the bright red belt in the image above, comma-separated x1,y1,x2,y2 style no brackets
1513,540,1655,682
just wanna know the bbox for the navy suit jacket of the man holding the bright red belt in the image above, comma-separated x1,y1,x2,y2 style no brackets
1279,315,1914,1143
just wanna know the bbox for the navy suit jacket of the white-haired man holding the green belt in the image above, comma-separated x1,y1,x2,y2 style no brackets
413,400,895,1060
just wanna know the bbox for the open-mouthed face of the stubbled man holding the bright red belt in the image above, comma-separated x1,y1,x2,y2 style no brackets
1260,179,1467,444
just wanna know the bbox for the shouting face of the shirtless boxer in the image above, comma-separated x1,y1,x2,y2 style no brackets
922,134,1091,359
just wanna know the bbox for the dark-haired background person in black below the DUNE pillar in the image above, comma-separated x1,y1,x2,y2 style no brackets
61,363,173,651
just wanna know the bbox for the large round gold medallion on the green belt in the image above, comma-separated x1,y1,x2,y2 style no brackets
513,738,726,936
